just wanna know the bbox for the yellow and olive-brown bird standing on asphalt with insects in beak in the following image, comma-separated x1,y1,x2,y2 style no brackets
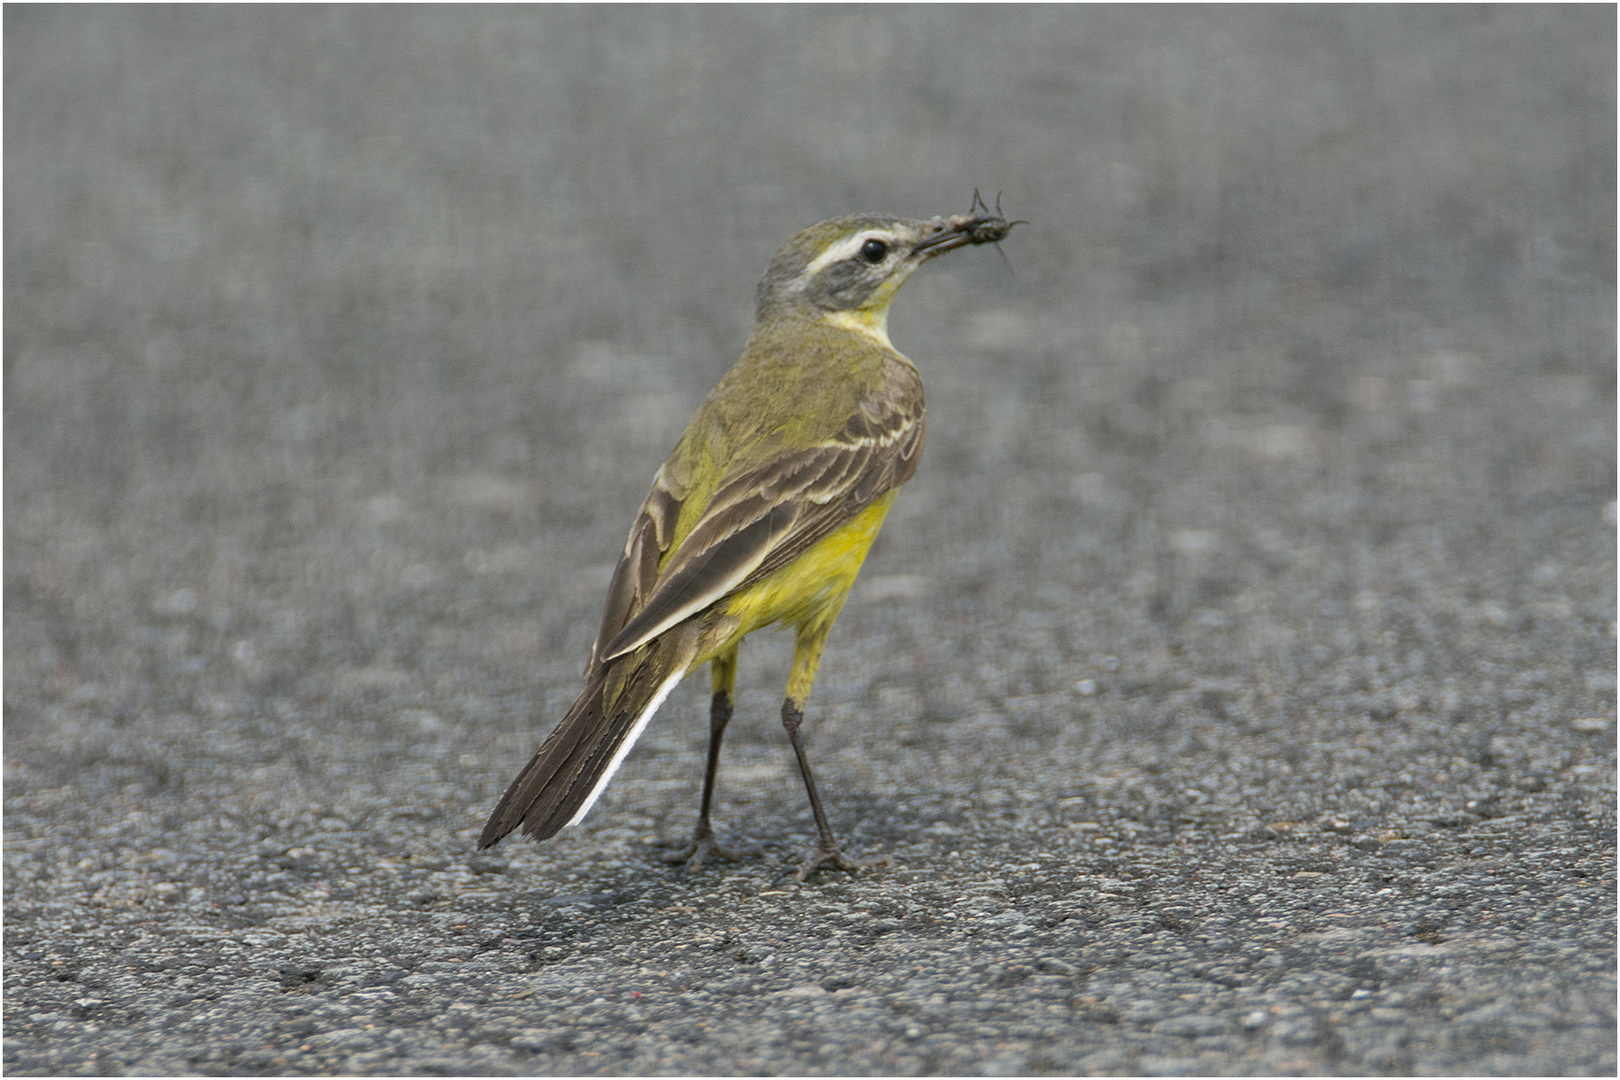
478,200,1022,882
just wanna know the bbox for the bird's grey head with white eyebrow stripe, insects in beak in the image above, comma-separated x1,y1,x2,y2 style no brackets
757,212,1011,340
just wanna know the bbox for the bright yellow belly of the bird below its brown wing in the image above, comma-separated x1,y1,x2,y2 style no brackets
724,491,896,643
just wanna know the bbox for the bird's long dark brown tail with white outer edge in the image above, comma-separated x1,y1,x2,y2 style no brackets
478,627,692,848
